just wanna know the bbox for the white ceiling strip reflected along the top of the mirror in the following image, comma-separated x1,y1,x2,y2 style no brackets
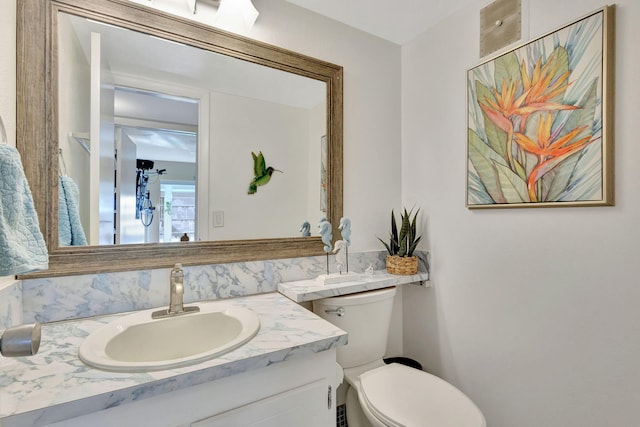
72,15,326,108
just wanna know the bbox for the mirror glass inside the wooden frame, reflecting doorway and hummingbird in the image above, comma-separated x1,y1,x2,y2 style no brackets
57,12,326,246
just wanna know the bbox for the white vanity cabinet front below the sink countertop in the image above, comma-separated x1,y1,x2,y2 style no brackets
47,349,336,427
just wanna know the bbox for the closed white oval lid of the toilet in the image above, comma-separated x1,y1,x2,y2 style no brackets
360,363,486,427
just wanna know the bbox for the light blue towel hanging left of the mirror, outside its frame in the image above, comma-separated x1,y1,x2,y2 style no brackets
0,144,49,276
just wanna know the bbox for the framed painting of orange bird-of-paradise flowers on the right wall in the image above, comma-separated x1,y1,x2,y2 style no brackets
467,6,614,208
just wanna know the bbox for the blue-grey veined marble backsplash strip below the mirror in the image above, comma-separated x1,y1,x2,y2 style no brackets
0,251,428,328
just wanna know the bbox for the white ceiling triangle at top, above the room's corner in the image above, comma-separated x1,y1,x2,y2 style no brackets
284,0,474,45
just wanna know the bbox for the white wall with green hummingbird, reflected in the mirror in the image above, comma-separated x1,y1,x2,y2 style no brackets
209,93,309,240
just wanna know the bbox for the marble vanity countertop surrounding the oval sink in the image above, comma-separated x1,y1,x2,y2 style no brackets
0,293,347,426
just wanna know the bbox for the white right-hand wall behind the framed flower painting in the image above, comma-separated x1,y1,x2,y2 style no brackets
402,0,640,427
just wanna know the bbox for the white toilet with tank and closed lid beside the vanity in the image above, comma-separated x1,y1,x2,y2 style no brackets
313,288,487,427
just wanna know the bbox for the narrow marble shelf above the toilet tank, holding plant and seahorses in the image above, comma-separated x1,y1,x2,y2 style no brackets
278,270,430,302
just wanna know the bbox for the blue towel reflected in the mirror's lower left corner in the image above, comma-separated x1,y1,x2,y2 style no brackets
58,176,87,246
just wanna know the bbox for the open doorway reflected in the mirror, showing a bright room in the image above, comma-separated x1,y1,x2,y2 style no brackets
110,87,199,244
